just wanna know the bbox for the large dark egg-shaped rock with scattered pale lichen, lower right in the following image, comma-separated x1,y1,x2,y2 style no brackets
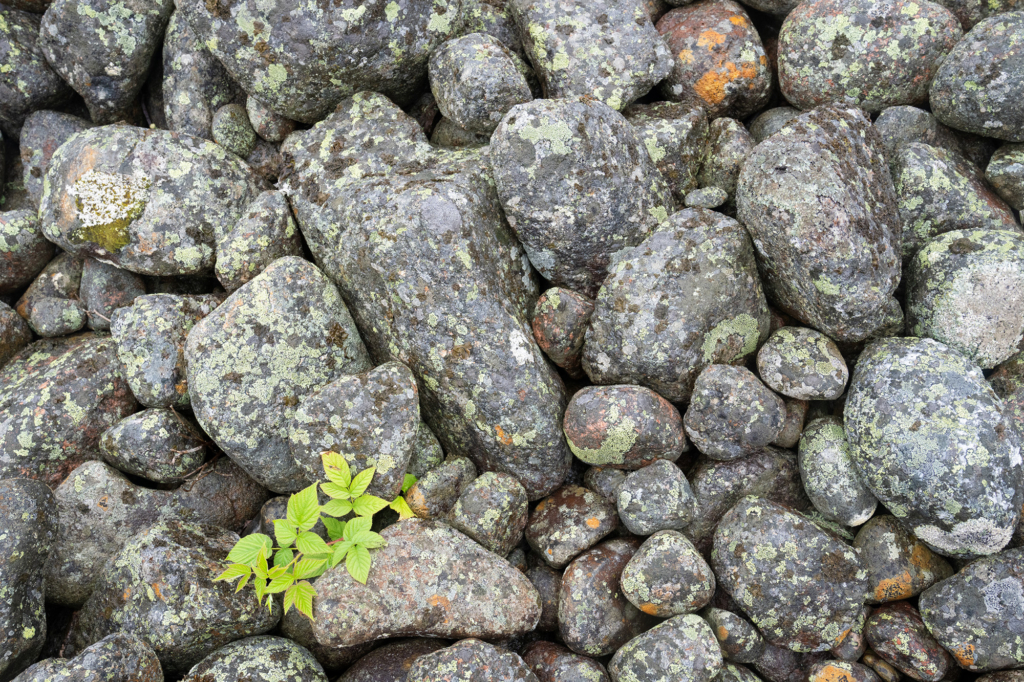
711,497,868,652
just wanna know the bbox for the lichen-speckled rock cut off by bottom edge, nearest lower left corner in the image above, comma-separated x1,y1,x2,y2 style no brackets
14,632,164,682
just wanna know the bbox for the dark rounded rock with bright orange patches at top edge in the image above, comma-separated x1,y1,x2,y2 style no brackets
657,0,771,119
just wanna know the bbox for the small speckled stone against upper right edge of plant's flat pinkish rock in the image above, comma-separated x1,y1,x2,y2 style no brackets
447,471,528,556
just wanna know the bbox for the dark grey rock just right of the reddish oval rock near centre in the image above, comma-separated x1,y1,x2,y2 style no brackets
683,365,785,460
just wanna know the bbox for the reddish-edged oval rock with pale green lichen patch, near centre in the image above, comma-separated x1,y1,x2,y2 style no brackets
562,386,688,469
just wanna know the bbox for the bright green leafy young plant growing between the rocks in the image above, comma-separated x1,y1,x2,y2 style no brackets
214,453,416,620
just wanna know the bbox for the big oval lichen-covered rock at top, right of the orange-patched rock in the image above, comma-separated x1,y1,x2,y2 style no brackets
778,0,963,113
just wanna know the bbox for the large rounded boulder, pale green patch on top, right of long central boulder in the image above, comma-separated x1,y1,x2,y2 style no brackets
490,96,673,296
